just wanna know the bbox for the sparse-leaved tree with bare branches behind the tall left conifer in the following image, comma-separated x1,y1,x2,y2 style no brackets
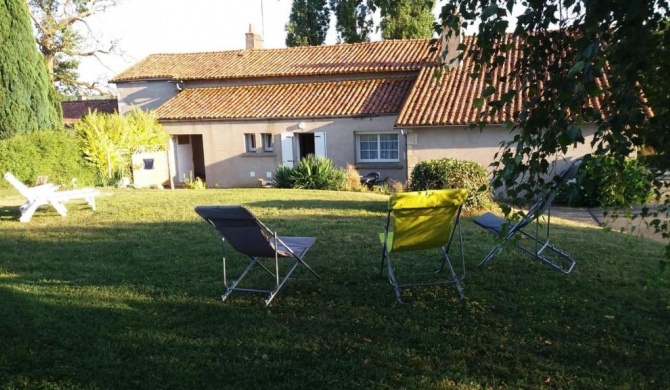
26,0,117,95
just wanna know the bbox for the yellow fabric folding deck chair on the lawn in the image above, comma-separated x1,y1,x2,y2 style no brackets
379,189,468,303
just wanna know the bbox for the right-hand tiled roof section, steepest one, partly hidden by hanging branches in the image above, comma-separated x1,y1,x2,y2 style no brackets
396,34,607,127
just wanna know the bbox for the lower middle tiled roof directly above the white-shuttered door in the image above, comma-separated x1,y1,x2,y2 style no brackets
156,77,414,120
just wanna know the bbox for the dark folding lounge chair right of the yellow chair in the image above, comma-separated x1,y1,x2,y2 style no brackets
474,160,581,274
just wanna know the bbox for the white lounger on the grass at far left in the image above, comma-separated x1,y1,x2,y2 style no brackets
5,172,100,222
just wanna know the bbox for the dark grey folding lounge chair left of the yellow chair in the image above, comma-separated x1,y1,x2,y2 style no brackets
195,206,319,306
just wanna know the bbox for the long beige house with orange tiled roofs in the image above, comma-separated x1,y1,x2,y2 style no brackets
111,29,595,187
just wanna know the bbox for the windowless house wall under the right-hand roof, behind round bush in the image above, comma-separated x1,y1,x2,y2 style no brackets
407,125,596,175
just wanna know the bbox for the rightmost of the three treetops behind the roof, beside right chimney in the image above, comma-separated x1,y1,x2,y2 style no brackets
375,0,435,39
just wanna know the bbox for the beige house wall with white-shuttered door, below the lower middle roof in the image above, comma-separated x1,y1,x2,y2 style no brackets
162,116,406,188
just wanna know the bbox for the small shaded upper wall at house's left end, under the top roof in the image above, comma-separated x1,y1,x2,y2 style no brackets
116,80,179,114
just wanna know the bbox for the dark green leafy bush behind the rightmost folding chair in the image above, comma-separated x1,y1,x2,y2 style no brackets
557,156,653,207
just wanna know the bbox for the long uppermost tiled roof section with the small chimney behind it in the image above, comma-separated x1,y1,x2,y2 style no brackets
111,39,436,83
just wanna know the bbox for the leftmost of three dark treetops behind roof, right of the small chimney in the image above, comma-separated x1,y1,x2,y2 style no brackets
286,0,330,47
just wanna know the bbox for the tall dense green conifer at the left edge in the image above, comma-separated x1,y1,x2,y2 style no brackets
0,0,62,139
